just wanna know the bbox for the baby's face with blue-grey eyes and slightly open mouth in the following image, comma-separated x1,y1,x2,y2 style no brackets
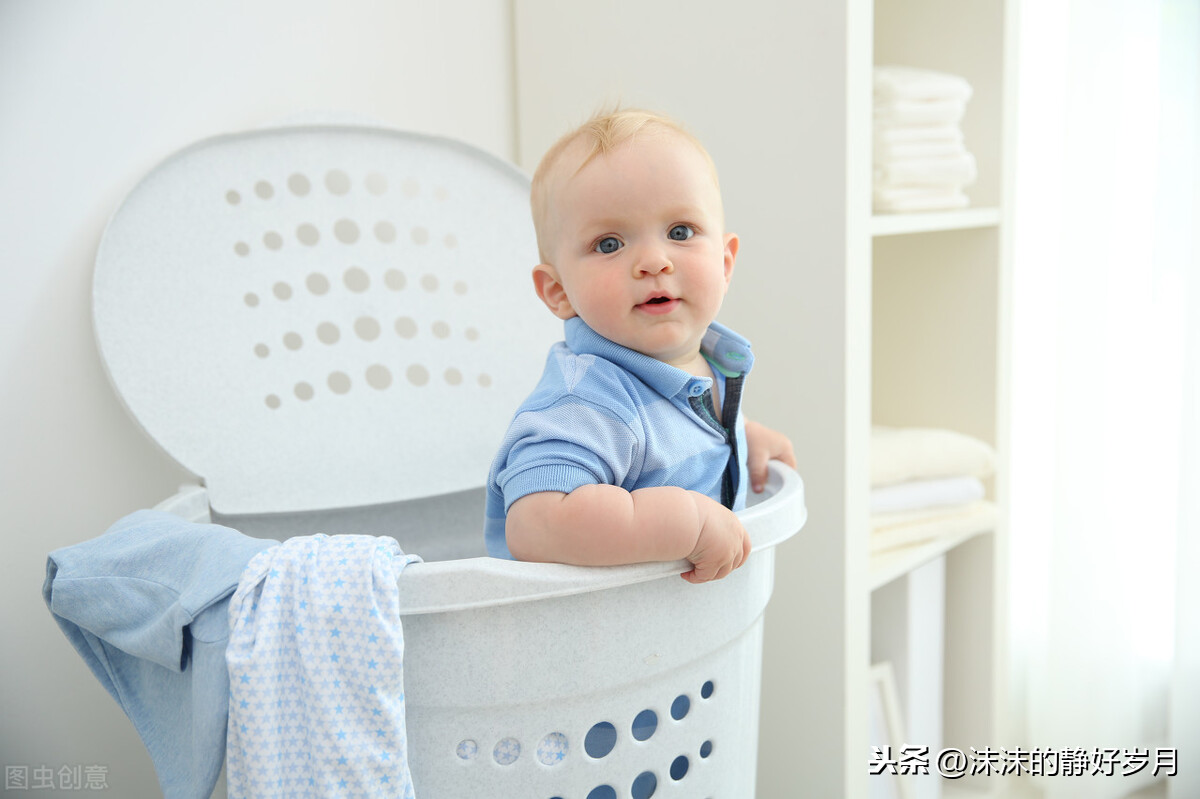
539,132,738,366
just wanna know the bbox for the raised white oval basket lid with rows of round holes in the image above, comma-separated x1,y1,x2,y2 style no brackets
92,125,562,513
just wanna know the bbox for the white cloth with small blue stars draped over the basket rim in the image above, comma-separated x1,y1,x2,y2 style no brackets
226,535,420,799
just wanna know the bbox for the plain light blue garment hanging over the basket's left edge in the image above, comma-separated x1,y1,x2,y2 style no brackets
42,510,278,799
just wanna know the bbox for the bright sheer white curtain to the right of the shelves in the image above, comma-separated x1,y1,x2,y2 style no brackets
1010,0,1200,799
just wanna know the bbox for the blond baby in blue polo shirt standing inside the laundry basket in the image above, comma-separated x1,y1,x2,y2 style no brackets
485,110,796,583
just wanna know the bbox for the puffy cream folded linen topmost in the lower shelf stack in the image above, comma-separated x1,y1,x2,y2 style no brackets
871,426,996,487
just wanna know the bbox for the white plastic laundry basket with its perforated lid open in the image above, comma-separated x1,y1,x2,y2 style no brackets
94,119,805,799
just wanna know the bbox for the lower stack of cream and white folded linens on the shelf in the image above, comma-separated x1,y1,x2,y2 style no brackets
870,427,996,554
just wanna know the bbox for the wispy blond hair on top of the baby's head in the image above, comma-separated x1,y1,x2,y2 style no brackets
529,108,720,263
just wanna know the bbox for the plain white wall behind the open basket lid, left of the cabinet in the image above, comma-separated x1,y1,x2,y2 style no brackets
0,0,514,797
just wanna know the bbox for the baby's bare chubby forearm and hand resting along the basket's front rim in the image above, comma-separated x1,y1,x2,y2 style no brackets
505,483,750,583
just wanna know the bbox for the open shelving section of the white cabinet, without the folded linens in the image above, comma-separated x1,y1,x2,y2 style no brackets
870,0,1015,795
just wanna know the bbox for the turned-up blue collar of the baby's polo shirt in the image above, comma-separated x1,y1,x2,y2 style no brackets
563,317,754,397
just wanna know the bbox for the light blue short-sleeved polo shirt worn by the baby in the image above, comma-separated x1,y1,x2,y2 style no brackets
484,317,754,558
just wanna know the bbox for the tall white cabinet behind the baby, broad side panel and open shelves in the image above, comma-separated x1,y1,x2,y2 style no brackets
512,0,1015,799
